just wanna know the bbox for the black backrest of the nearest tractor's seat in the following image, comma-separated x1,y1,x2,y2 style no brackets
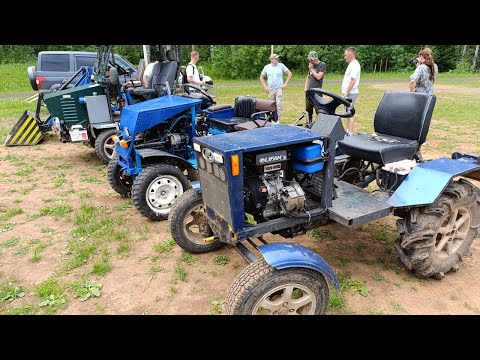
374,91,436,145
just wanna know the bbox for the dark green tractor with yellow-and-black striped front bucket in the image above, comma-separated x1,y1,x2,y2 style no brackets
5,45,131,163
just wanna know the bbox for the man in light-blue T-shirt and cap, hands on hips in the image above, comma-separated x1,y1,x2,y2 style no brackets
260,54,292,122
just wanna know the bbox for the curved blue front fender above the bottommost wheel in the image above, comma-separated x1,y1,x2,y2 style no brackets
258,243,340,291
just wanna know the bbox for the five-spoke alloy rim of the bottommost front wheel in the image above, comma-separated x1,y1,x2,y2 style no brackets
252,283,317,315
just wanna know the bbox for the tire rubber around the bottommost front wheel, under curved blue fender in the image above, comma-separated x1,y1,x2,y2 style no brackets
226,258,329,315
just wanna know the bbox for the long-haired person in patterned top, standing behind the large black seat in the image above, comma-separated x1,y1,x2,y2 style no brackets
409,48,438,95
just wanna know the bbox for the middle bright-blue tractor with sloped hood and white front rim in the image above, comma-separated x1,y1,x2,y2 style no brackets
107,84,276,220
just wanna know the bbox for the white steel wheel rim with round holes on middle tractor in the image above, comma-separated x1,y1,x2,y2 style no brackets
147,175,183,214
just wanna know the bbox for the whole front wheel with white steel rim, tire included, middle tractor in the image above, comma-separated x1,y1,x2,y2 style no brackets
132,164,190,221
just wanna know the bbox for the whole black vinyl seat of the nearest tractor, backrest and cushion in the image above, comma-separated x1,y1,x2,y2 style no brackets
338,91,436,165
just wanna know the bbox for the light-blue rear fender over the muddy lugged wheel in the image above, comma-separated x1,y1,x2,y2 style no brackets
387,157,480,208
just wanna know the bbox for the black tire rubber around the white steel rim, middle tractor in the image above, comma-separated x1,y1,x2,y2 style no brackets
132,164,191,221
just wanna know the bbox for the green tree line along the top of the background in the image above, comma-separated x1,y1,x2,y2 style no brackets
0,45,480,79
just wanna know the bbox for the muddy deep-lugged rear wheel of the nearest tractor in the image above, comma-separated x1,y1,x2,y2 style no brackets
395,179,480,280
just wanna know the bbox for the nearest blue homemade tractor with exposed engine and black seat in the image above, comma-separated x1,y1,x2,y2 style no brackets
169,89,480,315
